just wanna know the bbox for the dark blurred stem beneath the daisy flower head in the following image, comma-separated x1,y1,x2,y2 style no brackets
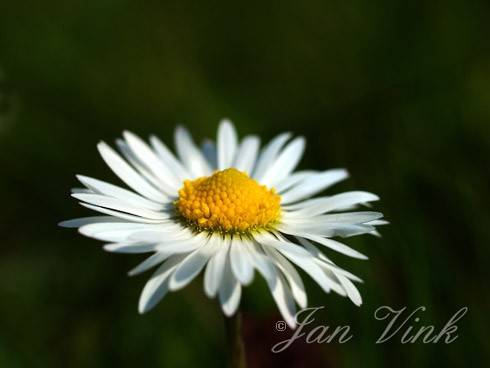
225,310,247,368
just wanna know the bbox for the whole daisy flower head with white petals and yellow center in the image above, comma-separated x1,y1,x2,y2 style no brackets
60,120,386,328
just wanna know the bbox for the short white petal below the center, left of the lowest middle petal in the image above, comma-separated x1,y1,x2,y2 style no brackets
204,236,230,298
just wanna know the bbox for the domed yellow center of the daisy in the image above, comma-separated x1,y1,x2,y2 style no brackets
175,168,281,233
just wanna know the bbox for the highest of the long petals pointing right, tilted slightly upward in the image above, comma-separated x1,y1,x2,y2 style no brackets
281,169,348,204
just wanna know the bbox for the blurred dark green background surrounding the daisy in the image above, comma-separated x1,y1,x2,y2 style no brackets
0,0,490,368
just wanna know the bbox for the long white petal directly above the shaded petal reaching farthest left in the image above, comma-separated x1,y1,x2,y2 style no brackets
71,193,170,220
